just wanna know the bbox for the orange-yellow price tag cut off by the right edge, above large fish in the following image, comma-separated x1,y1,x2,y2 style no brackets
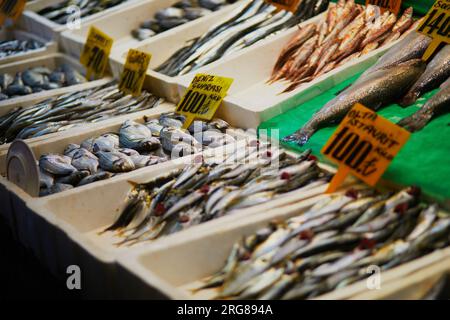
417,0,450,61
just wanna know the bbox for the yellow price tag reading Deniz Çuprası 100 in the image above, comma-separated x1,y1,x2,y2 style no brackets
176,74,233,129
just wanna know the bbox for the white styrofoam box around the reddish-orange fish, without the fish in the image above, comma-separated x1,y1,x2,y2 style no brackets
177,21,412,128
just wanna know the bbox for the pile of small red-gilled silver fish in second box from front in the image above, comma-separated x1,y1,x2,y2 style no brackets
105,147,330,245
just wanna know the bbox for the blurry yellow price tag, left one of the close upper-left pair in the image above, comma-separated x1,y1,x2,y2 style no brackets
80,27,114,79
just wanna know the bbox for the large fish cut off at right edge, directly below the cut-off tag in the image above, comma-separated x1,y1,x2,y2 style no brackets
400,45,450,106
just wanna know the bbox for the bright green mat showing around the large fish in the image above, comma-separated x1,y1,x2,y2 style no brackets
259,75,450,201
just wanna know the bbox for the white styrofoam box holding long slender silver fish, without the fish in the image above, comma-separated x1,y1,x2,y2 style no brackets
110,0,253,103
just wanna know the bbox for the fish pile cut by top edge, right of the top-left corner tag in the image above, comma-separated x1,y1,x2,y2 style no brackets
37,0,133,24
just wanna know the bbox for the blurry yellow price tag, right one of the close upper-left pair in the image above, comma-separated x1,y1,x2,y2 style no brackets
119,49,152,96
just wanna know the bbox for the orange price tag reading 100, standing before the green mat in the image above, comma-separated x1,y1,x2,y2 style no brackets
322,103,410,192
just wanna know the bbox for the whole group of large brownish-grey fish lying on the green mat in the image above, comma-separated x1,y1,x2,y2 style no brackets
284,32,450,145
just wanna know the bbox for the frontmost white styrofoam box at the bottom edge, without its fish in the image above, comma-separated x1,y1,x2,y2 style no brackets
118,200,450,300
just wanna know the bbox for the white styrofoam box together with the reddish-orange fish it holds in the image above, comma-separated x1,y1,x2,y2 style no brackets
179,1,417,127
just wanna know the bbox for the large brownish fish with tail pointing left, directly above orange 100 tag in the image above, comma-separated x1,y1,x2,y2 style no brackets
283,60,425,145
